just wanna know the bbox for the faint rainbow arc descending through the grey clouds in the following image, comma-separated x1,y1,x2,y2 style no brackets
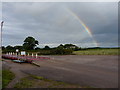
66,8,98,47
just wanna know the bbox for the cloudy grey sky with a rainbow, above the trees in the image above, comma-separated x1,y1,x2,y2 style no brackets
2,2,118,47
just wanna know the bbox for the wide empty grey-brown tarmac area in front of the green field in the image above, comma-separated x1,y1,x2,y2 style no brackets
2,55,118,88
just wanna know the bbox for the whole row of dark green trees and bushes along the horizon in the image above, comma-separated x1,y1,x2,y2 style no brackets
2,36,81,55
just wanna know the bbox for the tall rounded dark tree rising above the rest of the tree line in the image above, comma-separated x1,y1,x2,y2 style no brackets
23,36,39,50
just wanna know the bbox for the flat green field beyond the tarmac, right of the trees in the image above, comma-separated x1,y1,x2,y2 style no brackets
73,49,120,55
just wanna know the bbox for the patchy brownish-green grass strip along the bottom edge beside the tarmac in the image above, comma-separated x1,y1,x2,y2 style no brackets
14,75,89,88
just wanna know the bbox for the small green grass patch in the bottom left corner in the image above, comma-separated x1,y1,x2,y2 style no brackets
2,70,15,88
